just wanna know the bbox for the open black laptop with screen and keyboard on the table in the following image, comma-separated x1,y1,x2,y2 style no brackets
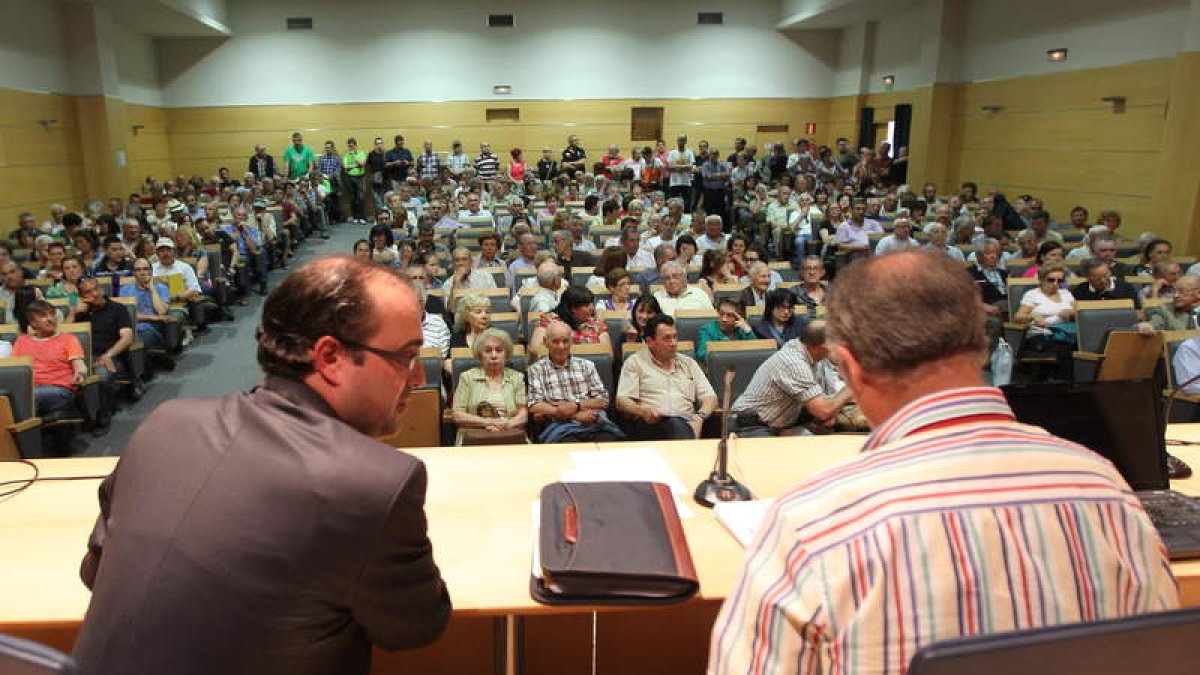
1003,380,1200,560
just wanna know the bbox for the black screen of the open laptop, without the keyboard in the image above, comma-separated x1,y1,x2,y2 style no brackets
1003,380,1169,490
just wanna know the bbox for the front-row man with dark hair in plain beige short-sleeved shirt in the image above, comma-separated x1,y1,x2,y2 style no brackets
617,315,716,441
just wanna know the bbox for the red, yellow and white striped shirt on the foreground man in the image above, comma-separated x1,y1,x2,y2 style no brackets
708,388,1178,675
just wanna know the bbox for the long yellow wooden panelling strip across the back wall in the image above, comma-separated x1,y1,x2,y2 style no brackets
167,98,828,175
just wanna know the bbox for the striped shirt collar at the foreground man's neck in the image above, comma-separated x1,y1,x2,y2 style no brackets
863,387,1016,452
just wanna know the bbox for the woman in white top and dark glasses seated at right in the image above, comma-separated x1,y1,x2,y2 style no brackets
1013,262,1075,382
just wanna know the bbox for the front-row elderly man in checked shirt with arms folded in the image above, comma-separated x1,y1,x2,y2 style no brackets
526,321,625,443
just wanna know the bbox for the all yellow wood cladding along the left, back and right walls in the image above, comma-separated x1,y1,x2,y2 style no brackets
0,59,1195,252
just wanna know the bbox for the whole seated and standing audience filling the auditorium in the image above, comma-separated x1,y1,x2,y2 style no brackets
9,126,1200,451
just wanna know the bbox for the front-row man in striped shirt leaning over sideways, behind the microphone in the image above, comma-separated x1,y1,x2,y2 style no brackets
730,319,852,437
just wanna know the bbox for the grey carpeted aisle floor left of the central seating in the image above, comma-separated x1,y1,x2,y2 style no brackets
81,218,367,456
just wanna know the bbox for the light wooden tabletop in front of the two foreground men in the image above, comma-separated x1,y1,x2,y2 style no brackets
7,424,1200,633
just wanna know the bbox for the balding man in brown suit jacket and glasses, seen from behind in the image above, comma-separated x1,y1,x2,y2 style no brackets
74,257,450,675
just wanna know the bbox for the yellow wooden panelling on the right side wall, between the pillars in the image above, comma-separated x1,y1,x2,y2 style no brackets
947,59,1174,235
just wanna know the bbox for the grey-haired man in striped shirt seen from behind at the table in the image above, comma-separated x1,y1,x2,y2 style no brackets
708,252,1180,675
